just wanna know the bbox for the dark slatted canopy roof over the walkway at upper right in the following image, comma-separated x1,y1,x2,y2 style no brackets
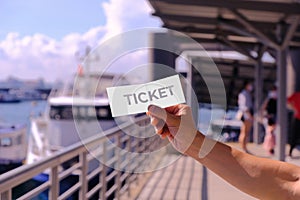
149,0,300,51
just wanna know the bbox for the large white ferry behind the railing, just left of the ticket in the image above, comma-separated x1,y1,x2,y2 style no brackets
26,63,116,167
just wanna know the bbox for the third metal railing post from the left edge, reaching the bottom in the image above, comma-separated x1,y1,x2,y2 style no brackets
79,151,88,200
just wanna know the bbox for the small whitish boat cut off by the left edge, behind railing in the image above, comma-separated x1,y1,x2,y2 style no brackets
0,123,27,174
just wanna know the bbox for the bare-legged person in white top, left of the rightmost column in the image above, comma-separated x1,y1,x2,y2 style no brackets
238,81,253,152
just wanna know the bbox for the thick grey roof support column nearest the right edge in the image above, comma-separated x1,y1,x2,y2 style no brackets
275,49,287,161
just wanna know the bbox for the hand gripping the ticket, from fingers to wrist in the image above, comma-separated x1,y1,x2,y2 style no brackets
147,104,197,153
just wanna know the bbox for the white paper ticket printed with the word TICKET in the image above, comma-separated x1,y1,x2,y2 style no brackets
106,75,185,117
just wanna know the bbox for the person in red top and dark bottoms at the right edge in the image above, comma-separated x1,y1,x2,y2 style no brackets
288,91,300,156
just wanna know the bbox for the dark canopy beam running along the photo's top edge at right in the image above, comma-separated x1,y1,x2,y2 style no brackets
149,0,300,14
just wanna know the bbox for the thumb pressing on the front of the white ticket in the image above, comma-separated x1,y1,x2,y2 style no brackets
148,105,178,125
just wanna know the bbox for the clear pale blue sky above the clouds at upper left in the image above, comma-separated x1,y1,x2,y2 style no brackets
0,0,106,40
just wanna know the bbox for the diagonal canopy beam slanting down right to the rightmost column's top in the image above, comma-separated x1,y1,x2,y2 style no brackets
230,10,280,49
